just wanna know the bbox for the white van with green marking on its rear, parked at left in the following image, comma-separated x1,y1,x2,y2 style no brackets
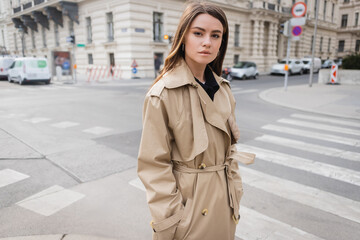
8,57,51,85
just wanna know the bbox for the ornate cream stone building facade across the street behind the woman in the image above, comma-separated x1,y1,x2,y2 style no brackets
0,0,360,78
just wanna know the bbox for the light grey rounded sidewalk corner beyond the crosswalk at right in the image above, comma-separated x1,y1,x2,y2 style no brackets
259,84,360,120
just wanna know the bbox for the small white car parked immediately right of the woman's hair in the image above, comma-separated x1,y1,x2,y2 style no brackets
223,61,259,81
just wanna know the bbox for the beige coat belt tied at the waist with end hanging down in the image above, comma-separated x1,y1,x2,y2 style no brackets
173,159,240,224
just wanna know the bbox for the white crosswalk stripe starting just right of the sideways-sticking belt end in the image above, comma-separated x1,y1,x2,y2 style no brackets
255,135,360,162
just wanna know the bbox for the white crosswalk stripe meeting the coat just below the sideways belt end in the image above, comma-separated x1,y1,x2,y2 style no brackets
236,144,360,186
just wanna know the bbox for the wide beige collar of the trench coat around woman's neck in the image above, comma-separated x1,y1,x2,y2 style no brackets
163,59,229,89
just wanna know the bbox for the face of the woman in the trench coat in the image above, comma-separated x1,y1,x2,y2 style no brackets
185,14,223,65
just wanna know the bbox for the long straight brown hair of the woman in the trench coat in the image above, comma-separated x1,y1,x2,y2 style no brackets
154,2,229,84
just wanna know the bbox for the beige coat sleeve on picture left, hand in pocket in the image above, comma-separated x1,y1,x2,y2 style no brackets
138,95,184,240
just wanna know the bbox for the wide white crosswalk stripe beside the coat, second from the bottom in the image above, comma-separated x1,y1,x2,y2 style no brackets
239,166,360,223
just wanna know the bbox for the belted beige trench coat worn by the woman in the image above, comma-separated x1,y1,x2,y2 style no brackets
138,58,254,240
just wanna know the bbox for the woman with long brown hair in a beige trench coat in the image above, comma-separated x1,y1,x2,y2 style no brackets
138,3,254,240
